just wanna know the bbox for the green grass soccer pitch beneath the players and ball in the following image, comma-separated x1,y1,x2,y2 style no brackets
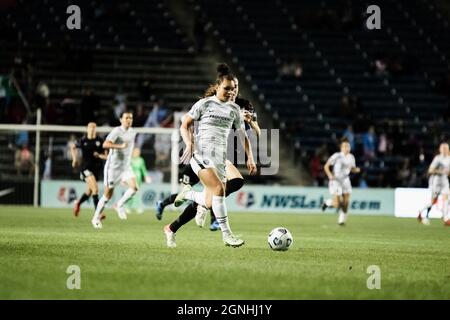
0,207,450,299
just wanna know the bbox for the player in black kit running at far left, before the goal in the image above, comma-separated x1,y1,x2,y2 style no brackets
70,122,107,217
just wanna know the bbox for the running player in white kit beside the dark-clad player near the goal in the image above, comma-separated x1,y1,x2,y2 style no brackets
92,112,138,229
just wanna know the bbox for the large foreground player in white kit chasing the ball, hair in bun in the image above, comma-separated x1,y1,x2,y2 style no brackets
164,65,256,247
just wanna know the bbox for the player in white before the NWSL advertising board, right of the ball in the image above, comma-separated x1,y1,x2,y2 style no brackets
322,138,361,225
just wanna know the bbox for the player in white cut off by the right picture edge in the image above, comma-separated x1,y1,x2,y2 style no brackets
417,142,450,225
